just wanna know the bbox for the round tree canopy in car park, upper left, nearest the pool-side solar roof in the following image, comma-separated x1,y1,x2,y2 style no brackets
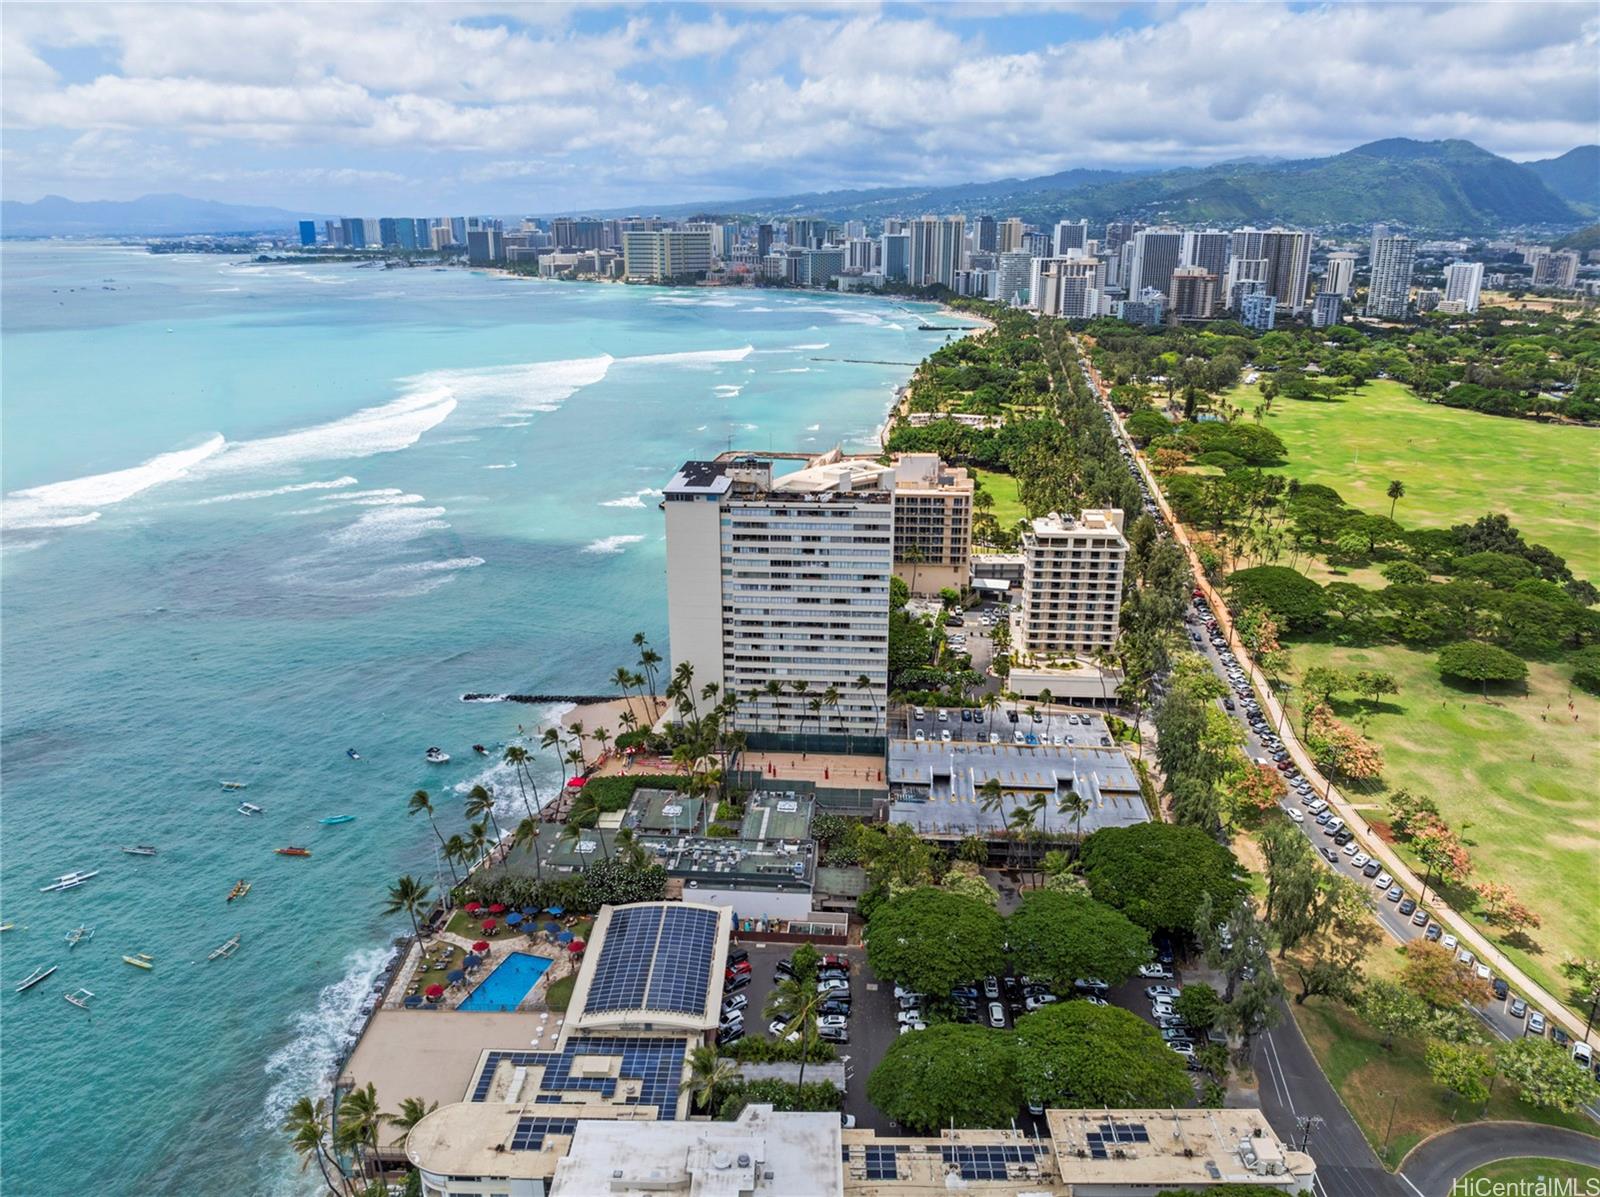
866,885,1005,994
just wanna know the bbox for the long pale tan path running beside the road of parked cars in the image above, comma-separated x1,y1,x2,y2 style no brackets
1074,338,1586,1040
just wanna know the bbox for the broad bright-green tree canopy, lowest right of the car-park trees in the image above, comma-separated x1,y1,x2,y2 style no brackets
1016,1002,1194,1109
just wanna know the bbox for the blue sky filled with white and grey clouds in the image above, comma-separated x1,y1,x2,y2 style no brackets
0,0,1600,214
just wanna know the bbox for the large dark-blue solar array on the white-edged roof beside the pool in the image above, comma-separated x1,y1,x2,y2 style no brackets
584,906,718,1015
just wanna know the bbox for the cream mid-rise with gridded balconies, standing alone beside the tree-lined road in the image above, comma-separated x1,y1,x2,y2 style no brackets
1011,509,1128,658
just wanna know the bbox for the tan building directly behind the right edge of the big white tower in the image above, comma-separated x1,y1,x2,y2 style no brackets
894,453,973,595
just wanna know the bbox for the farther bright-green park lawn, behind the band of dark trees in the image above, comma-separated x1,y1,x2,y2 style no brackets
1235,382,1600,579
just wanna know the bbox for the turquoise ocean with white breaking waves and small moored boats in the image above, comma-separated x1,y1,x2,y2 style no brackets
0,243,949,1197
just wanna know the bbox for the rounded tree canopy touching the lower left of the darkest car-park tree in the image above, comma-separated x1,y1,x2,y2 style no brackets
1006,890,1150,989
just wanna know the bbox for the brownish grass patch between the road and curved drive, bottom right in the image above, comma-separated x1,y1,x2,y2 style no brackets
1290,979,1594,1168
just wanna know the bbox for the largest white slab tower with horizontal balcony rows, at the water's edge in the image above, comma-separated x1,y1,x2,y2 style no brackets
664,450,894,743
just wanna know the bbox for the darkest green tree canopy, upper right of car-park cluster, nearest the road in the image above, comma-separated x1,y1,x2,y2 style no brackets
1082,823,1246,933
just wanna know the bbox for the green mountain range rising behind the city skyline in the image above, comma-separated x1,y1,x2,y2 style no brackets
649,138,1600,234
